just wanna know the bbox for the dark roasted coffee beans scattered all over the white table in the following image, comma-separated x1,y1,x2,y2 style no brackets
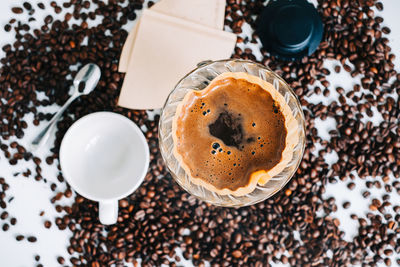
0,0,400,266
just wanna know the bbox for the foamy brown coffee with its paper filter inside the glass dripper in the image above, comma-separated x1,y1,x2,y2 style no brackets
172,73,298,196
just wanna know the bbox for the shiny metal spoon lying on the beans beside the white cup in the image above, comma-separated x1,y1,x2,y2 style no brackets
31,63,101,149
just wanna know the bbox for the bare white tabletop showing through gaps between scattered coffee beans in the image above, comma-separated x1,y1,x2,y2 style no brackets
0,0,400,267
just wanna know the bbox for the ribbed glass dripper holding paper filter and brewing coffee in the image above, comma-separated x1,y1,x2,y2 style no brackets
159,60,304,206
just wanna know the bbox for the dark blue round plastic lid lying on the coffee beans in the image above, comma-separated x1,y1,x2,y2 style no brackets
257,0,323,60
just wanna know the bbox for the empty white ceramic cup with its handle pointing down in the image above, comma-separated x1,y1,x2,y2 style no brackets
60,112,149,224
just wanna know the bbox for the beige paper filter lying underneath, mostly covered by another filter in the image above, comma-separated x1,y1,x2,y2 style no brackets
118,0,226,72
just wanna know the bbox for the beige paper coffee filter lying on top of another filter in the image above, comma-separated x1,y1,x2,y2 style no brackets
118,9,236,109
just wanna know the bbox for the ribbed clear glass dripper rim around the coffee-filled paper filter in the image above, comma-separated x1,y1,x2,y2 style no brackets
159,59,305,207
